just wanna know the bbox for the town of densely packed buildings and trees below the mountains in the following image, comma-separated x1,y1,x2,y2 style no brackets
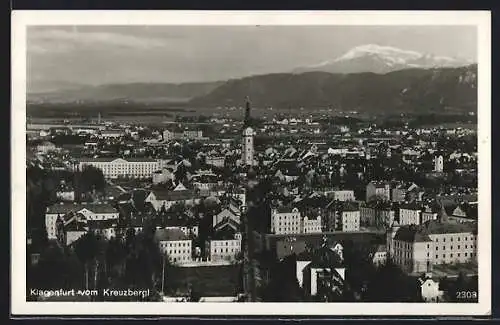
26,98,478,302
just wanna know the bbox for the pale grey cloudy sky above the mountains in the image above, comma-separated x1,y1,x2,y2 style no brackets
27,26,477,92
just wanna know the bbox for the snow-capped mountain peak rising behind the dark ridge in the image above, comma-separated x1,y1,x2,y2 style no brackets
294,44,474,73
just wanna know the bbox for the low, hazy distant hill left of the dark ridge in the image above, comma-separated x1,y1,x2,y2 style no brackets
28,82,223,102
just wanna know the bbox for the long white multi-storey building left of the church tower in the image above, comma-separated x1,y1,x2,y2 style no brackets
77,158,159,178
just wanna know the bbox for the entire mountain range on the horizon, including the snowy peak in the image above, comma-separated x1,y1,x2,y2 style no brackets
28,45,477,111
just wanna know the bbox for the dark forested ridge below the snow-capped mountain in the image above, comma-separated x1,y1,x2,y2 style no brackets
189,64,477,112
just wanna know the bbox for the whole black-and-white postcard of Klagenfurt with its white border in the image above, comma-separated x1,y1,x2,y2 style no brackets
11,11,491,315
